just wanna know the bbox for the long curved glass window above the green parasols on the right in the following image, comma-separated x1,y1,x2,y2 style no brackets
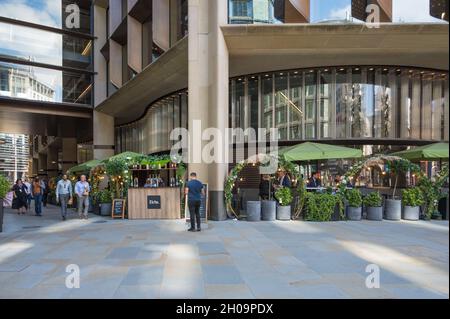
230,66,449,141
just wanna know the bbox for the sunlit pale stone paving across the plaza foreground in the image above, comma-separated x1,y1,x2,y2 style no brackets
0,208,449,299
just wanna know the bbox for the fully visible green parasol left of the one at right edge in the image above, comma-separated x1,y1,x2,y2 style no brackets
279,142,362,162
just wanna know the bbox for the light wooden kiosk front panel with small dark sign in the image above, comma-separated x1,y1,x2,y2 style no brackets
128,187,181,219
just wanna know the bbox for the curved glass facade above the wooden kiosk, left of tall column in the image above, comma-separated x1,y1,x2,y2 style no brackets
116,91,188,154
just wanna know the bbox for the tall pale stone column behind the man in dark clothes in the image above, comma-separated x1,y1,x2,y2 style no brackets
188,0,229,220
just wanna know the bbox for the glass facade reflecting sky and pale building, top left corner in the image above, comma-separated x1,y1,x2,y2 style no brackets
0,0,93,105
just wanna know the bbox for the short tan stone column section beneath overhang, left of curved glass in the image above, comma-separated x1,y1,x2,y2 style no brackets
93,110,115,160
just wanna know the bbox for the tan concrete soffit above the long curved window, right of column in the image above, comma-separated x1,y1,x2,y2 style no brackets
221,23,449,77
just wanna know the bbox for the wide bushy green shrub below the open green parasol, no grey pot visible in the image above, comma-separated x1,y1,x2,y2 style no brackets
305,193,339,222
